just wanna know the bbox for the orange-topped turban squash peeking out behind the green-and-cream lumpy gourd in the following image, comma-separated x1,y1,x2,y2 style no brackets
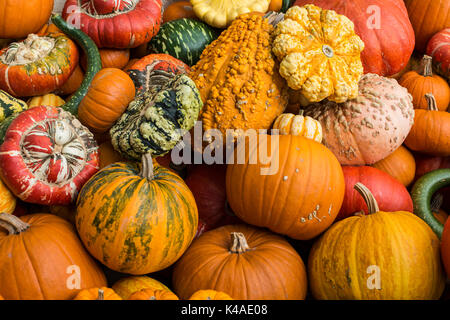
126,53,191,93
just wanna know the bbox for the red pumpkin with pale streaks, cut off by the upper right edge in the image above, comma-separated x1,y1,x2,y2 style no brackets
427,28,450,80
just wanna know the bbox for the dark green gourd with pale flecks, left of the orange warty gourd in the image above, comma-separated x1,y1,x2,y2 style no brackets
147,18,219,66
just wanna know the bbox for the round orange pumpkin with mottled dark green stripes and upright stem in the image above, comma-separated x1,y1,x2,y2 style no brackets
75,155,198,275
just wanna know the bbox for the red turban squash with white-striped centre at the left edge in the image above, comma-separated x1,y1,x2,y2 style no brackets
0,106,99,205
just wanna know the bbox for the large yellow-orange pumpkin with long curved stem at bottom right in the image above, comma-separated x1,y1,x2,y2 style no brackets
308,184,445,300
